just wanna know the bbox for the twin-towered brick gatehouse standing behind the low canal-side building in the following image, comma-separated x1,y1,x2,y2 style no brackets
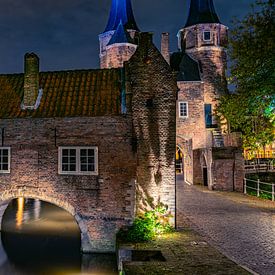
99,0,244,191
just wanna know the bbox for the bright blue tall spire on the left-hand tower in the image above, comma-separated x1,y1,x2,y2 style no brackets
104,0,139,32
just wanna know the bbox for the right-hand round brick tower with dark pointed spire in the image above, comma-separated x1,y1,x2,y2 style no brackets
178,0,228,124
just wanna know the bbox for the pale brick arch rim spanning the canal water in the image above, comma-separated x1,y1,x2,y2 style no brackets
0,189,92,253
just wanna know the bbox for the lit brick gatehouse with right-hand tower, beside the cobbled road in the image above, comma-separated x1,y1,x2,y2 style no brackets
171,0,244,191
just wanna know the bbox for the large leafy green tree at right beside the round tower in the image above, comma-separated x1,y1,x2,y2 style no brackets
217,0,275,149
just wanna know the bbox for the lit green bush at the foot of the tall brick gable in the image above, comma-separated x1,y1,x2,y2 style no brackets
118,205,173,242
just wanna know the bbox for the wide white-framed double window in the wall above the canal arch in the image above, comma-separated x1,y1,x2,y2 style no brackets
58,146,98,175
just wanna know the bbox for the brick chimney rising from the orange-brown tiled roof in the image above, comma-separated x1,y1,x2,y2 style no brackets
23,53,39,109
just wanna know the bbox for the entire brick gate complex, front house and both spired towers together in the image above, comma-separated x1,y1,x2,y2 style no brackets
0,0,246,252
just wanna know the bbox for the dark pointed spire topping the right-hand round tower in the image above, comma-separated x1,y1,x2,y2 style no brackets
185,0,220,28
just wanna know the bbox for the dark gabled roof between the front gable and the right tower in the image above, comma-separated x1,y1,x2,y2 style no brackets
170,52,201,81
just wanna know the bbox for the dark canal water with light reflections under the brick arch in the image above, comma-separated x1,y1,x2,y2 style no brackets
0,198,117,275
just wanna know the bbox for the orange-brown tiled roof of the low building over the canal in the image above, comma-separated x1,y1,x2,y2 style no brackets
0,69,121,118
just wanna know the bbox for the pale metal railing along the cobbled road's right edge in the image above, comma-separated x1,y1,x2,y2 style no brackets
244,178,275,201
